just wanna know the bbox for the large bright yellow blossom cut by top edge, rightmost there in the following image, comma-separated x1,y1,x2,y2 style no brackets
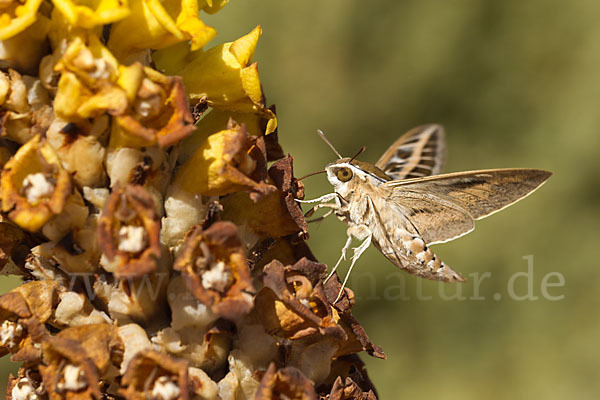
108,0,217,59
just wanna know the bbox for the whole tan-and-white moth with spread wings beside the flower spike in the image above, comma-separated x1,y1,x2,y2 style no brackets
299,124,552,301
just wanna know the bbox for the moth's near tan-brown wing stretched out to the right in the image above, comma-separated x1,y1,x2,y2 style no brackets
385,169,552,244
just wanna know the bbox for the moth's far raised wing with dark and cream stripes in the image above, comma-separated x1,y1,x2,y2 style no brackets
375,124,446,180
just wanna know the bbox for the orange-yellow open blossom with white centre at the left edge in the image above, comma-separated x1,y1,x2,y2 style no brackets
0,136,72,231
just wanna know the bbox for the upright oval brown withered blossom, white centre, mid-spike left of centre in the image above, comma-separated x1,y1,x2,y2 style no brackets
97,185,161,277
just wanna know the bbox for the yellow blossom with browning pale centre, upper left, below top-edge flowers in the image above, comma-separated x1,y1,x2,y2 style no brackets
54,34,128,120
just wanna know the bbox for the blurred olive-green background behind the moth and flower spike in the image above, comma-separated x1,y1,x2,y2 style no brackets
0,0,600,400
